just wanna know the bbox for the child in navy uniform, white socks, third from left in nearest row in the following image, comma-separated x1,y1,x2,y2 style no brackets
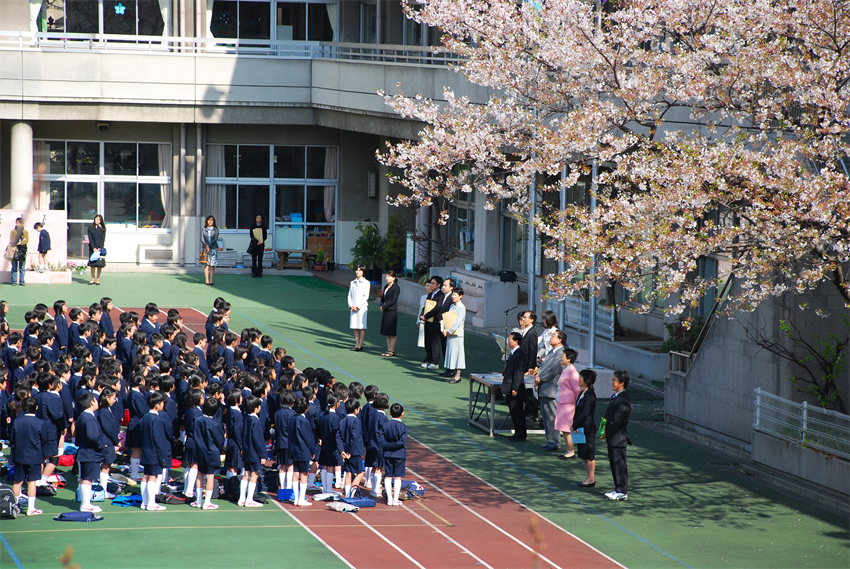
140,391,171,512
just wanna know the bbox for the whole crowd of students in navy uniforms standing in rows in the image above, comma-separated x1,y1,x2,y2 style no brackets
0,298,407,515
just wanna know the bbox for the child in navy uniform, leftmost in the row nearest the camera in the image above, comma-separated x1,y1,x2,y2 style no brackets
9,397,47,516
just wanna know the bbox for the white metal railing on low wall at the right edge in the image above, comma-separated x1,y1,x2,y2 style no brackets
753,387,850,460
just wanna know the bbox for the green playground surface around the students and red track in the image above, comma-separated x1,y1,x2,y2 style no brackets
0,274,850,569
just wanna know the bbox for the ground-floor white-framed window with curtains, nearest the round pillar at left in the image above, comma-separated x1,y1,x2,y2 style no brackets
33,140,172,257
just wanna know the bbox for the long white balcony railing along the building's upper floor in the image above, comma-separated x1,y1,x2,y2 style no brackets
0,31,459,66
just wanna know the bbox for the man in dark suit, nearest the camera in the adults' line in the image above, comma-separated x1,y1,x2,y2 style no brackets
602,370,632,500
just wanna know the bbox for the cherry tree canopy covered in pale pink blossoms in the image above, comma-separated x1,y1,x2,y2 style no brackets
379,0,850,313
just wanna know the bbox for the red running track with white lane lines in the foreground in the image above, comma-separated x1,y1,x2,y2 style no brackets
274,439,622,569
